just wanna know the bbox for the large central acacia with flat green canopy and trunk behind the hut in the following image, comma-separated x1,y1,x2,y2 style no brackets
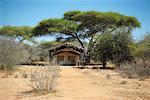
33,11,140,63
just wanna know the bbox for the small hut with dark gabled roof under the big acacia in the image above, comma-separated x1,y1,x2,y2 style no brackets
49,43,84,65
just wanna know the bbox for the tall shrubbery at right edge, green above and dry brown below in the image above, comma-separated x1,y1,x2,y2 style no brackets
119,34,150,78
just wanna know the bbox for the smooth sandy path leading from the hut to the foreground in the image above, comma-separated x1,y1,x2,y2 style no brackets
56,68,111,100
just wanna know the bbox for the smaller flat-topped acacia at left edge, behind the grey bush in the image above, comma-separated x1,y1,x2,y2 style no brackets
0,26,33,43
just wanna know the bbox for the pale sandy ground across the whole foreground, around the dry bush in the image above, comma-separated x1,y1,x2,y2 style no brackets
0,67,150,100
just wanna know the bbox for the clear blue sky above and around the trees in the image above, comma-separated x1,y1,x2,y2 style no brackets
0,0,150,40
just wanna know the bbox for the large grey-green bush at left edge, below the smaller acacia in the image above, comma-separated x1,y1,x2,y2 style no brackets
0,36,29,70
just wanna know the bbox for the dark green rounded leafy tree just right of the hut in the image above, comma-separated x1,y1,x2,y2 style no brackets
92,29,134,67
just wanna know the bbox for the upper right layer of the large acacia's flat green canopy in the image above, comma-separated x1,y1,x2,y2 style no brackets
64,11,140,32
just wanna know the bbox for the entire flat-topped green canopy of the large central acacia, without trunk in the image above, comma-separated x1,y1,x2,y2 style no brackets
33,11,140,36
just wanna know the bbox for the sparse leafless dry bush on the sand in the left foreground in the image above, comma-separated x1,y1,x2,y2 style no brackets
28,66,60,95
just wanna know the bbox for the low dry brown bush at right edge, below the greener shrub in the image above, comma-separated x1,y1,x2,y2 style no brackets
118,60,150,78
